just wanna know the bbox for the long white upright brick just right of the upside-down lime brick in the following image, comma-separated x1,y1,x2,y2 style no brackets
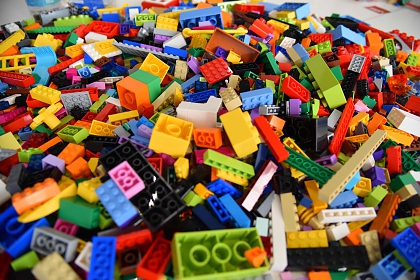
270,195,287,272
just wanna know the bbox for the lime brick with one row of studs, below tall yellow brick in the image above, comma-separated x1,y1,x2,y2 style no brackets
203,149,255,179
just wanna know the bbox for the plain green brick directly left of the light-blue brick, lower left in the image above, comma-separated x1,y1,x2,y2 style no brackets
58,196,100,229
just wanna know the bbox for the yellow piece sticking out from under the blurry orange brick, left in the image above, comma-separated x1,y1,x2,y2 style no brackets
18,176,77,223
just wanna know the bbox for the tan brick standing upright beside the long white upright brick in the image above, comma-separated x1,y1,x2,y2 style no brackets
280,193,300,232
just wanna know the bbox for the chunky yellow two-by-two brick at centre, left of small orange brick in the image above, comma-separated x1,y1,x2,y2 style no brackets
149,114,194,158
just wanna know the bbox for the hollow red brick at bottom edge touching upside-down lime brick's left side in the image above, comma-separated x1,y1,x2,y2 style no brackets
136,236,172,280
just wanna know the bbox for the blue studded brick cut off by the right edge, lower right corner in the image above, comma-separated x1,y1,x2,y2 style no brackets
391,228,420,275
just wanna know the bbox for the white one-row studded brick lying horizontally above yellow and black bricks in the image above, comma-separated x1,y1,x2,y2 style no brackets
318,207,376,224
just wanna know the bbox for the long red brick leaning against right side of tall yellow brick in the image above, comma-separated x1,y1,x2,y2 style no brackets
254,116,289,162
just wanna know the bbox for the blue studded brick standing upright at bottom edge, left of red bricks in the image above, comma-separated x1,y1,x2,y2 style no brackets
87,236,117,280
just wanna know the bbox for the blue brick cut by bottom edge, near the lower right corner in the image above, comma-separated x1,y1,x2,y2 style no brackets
370,253,408,280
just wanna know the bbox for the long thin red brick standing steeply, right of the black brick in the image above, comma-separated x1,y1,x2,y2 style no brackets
328,98,354,156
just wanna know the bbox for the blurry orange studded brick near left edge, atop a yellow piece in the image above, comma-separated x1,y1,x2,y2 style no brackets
12,178,60,215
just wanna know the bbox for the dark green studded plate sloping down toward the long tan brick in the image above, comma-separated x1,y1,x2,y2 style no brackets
284,146,334,188
